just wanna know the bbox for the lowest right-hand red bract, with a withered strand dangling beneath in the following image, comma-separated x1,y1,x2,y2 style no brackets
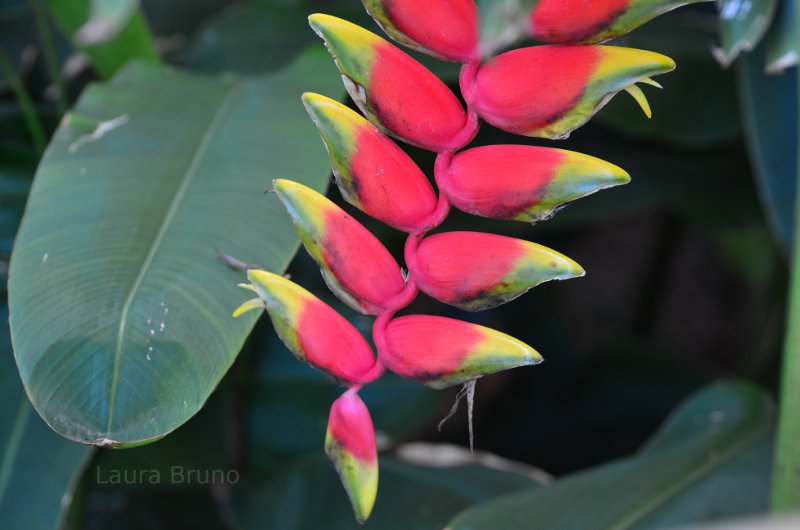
378,315,542,388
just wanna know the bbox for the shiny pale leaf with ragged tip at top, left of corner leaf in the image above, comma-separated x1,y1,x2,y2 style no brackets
714,0,778,67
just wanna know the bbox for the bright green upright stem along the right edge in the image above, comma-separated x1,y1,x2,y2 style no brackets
772,64,800,512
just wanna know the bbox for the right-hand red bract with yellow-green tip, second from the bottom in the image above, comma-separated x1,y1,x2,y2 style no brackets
408,232,585,311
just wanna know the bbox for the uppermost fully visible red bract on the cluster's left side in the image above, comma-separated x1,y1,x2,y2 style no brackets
309,14,467,151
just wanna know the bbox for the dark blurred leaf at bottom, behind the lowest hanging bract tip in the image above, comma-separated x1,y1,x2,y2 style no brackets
233,454,536,530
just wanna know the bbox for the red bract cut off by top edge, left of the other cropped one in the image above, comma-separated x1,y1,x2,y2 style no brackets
363,0,480,63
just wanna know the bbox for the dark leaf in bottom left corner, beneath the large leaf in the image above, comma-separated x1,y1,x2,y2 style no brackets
0,304,92,530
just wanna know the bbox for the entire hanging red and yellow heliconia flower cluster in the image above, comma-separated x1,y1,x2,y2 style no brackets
235,0,689,522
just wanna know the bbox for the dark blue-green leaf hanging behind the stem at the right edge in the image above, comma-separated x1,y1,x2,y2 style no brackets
736,42,798,249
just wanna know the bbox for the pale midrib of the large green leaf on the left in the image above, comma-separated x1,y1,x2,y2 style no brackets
105,83,241,443
